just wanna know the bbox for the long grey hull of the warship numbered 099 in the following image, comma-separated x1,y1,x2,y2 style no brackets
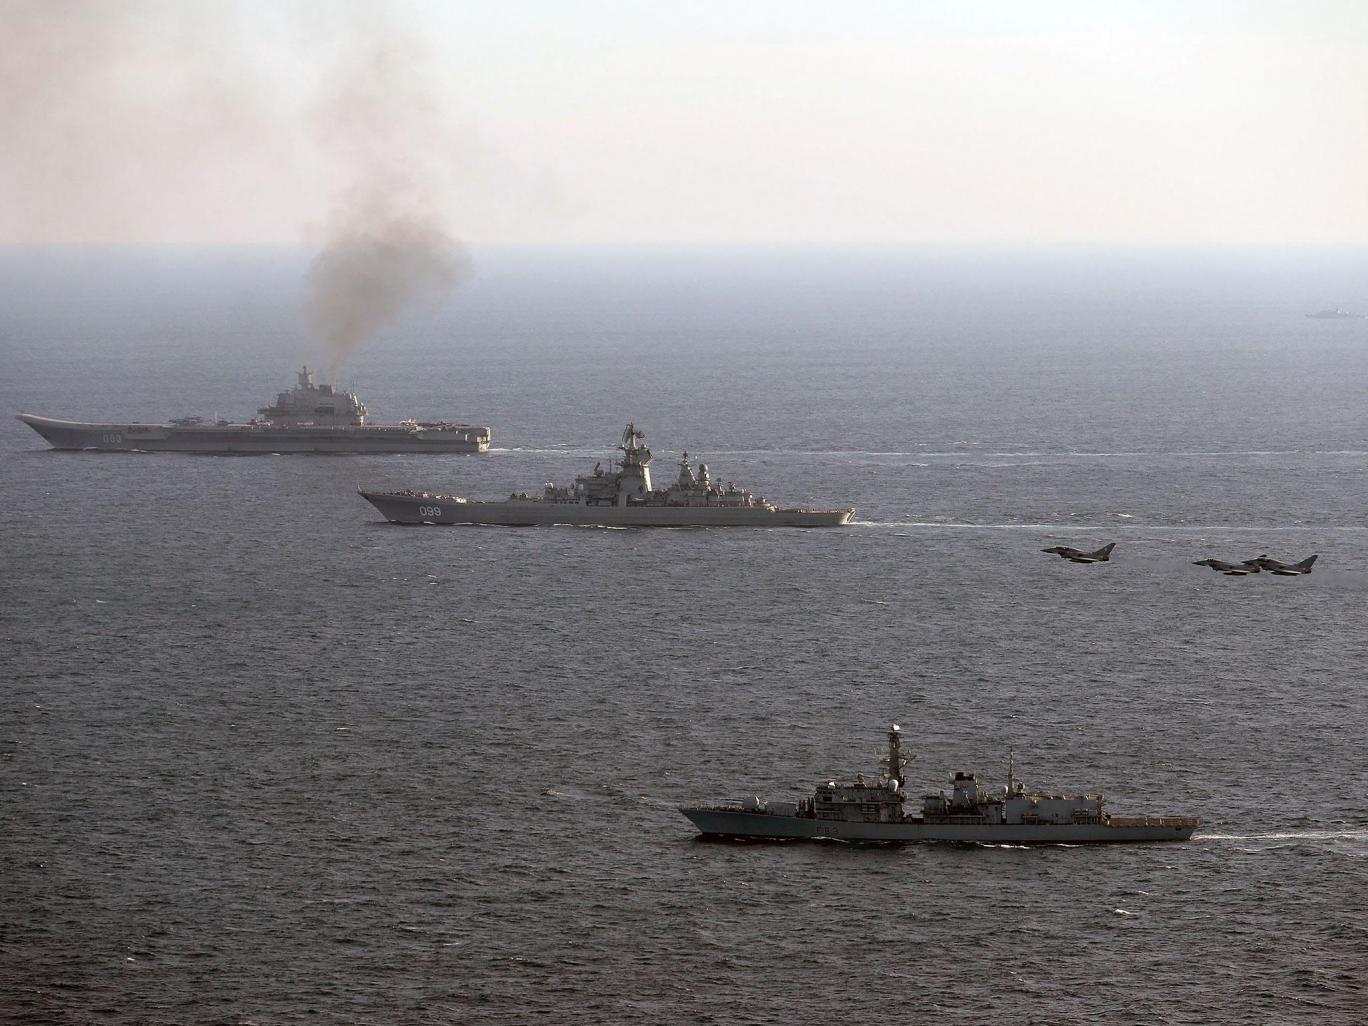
361,491,854,527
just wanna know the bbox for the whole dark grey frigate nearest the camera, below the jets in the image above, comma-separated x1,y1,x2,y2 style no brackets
680,724,1201,844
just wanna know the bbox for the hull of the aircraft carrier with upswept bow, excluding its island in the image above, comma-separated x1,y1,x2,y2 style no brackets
19,413,490,456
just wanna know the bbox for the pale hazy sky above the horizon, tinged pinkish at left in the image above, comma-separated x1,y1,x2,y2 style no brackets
0,0,1368,246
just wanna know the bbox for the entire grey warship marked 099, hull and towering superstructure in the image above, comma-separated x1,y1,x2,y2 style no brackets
361,424,855,527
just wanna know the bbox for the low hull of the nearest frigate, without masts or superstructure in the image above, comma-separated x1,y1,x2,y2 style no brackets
680,808,1197,844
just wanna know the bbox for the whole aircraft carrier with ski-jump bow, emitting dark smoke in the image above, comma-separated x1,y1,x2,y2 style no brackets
19,367,490,456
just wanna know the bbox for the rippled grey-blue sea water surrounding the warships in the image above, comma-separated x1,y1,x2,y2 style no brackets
0,250,1368,1026
